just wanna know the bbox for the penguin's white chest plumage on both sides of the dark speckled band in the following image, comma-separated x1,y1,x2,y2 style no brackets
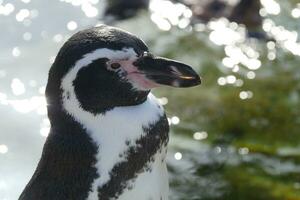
64,94,168,200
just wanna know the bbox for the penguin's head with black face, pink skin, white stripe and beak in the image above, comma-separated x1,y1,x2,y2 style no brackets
46,25,200,114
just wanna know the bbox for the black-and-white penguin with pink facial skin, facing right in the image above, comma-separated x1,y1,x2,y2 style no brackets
19,25,200,200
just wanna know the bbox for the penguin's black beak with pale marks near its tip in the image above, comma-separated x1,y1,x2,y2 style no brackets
134,54,201,87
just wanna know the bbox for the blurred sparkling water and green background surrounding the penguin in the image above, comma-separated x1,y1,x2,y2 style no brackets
0,0,300,200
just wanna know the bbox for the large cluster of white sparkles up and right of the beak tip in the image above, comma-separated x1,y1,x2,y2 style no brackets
208,18,262,81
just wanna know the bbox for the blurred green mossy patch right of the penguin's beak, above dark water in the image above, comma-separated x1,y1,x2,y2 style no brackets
156,31,300,149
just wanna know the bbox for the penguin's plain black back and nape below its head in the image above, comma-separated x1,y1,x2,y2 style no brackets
20,101,99,200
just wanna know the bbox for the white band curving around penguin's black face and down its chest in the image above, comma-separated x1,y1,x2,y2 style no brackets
61,49,167,200
